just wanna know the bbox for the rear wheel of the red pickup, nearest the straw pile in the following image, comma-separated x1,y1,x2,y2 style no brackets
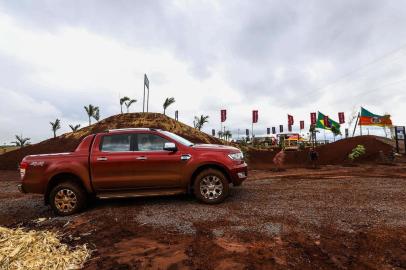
49,182,87,216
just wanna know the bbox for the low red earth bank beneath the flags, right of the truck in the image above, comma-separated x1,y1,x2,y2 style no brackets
248,136,393,169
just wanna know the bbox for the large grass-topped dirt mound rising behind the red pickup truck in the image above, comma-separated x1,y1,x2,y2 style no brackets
0,113,222,170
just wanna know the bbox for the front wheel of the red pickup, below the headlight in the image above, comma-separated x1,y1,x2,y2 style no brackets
193,169,230,204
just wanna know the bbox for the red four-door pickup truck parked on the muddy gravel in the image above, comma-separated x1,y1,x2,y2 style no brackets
19,128,247,215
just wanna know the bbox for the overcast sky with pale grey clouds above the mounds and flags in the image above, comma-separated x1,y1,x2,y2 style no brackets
0,0,406,144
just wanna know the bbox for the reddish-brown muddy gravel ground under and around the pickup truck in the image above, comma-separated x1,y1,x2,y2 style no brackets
0,163,406,269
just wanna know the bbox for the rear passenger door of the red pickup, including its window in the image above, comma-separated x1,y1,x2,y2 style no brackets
90,133,137,191
